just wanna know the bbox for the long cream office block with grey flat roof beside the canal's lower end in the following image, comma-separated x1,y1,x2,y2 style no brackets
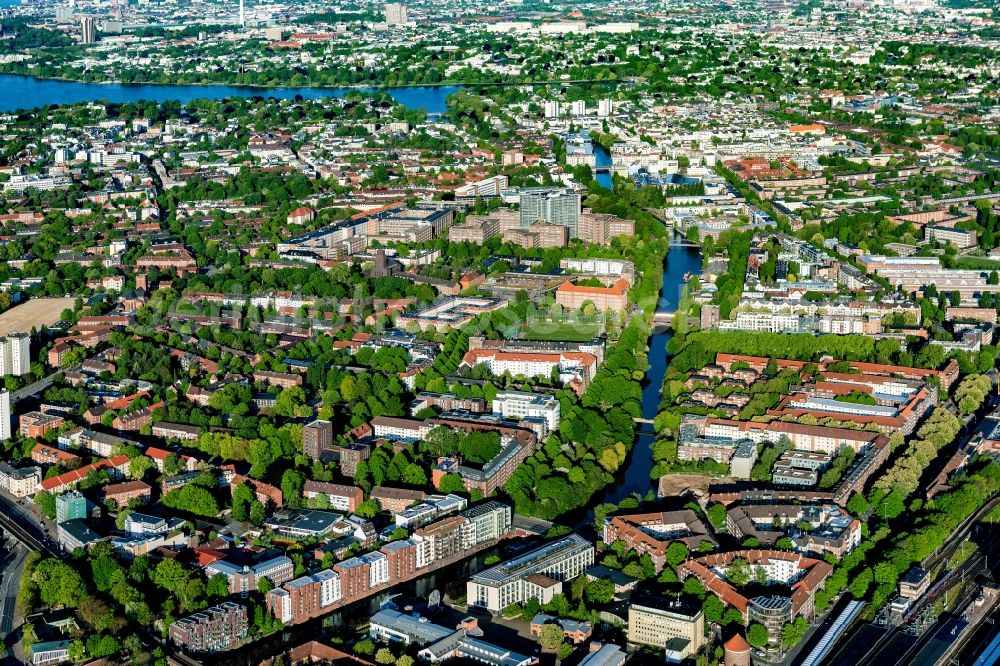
467,534,594,613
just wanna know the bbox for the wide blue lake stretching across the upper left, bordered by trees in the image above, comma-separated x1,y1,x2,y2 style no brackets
0,74,458,113
